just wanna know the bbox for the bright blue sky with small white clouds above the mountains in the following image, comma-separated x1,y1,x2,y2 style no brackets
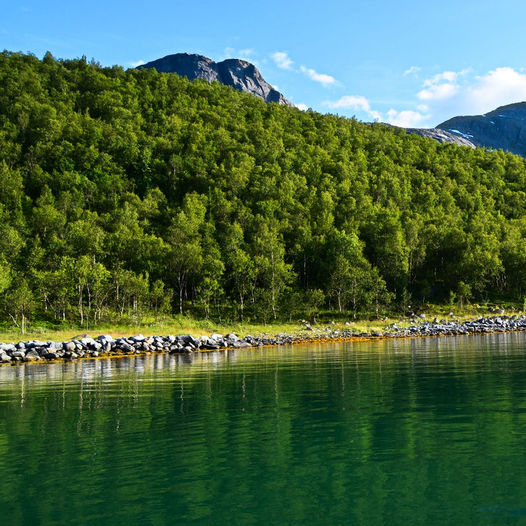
4,0,526,127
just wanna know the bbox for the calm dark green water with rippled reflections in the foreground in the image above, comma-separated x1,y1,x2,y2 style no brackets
0,334,526,526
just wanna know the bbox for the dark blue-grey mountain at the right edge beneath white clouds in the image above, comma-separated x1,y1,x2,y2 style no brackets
436,102,526,156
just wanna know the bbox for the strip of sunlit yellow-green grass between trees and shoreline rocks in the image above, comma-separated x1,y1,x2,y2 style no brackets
0,304,520,342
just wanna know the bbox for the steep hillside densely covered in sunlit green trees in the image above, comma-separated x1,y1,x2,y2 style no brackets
0,52,526,325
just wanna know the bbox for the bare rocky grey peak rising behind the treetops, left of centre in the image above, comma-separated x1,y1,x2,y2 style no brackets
138,53,294,106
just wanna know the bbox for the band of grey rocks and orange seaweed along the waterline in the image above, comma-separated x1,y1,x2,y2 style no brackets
0,316,526,365
